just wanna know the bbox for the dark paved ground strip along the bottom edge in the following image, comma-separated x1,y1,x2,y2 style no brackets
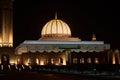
0,72,120,80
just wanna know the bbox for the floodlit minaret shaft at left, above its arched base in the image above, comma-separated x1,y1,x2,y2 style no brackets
0,0,13,47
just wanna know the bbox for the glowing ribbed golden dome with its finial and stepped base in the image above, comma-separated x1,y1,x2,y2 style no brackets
39,15,81,41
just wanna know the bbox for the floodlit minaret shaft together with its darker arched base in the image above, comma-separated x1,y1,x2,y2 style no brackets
0,0,15,64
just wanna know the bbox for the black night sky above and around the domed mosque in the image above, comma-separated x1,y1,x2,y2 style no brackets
13,0,120,49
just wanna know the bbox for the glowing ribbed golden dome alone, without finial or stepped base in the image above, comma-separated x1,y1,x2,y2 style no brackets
41,18,71,37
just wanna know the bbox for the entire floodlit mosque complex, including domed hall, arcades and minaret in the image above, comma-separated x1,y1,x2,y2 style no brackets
0,0,120,66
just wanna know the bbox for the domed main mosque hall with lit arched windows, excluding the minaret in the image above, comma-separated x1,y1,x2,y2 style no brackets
15,17,118,65
